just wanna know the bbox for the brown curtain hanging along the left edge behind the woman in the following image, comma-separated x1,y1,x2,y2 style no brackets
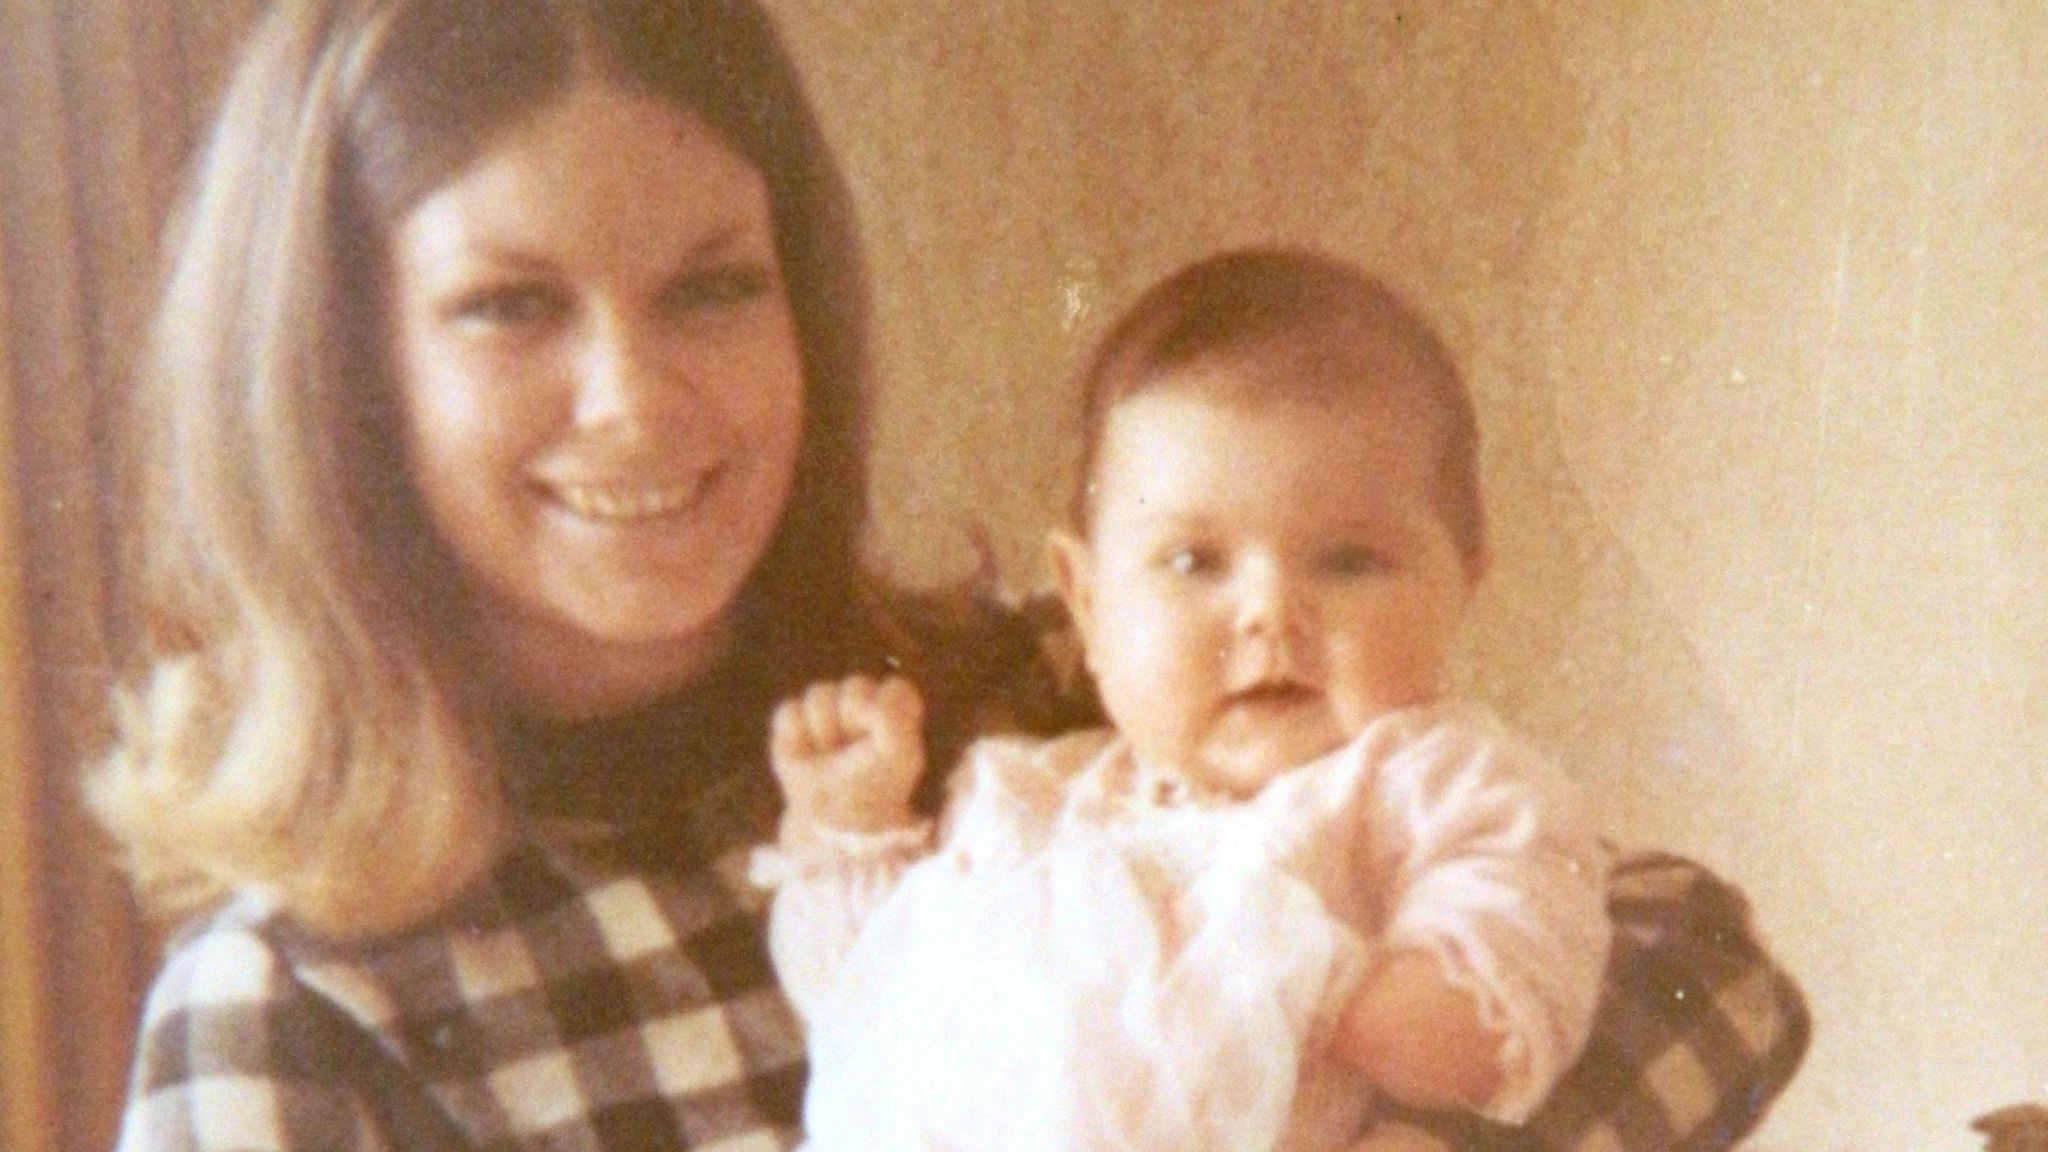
0,0,268,1152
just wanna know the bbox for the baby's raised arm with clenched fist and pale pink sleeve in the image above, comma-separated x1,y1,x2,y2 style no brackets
756,676,930,1019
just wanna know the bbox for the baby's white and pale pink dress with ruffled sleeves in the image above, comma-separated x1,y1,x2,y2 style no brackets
758,705,1610,1152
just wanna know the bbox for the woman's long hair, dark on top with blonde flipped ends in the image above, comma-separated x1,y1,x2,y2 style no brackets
88,0,866,935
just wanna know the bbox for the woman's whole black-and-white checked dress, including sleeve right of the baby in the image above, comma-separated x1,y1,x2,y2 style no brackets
119,590,1808,1152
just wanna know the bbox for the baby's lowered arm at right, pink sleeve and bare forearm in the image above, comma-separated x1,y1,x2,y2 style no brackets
1333,709,1612,1121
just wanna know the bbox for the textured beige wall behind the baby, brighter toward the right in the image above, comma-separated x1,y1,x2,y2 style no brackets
780,0,2048,1152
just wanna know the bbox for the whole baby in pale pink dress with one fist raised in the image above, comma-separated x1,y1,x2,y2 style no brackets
758,250,1610,1152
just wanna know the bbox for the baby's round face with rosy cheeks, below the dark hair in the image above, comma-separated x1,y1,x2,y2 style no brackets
1053,381,1475,795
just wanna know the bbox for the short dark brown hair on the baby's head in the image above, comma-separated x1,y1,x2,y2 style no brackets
1071,248,1487,564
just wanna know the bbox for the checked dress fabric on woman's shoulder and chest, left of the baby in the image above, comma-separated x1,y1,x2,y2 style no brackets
119,849,803,1152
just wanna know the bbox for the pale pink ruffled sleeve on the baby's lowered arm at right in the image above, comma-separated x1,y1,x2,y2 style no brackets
1366,705,1612,1123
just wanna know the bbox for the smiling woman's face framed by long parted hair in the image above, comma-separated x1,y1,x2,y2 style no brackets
387,84,803,711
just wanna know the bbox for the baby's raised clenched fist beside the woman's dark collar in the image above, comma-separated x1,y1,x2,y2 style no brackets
768,676,924,832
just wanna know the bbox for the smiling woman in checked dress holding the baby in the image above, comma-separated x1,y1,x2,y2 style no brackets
92,0,1798,1152
